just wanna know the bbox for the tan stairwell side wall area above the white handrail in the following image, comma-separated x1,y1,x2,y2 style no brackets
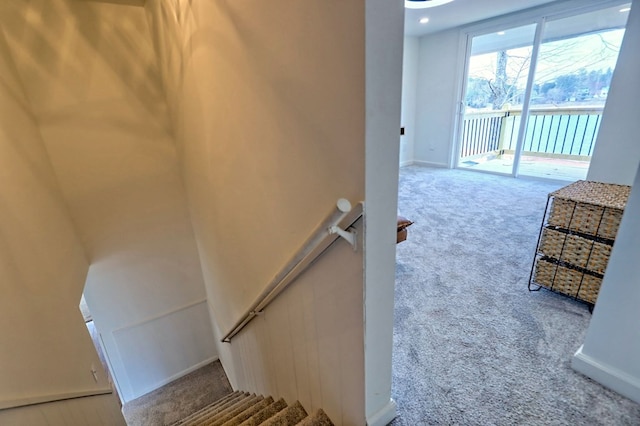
147,1,364,330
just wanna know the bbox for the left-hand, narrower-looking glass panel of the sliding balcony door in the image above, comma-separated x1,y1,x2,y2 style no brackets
458,24,536,174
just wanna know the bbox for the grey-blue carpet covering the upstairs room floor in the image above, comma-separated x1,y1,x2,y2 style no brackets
392,166,640,426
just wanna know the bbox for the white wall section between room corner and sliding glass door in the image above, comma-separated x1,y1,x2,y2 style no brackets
414,30,462,167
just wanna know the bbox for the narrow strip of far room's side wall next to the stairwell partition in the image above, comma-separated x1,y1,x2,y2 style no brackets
400,36,420,167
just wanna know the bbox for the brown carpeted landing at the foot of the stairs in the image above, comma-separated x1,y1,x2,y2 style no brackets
122,361,233,426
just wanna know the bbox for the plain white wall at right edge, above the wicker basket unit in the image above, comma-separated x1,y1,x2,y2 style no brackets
587,0,640,185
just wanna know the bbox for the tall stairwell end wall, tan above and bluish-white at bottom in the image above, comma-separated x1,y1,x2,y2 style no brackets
0,0,217,401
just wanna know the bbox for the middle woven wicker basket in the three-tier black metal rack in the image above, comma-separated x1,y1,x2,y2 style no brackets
539,228,611,274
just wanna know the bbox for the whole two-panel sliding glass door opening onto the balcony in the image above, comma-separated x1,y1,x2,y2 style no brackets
457,5,628,181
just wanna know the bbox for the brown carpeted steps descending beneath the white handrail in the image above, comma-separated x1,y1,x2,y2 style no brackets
172,391,333,426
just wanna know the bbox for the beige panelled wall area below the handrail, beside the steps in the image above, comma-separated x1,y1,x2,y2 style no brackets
211,221,364,425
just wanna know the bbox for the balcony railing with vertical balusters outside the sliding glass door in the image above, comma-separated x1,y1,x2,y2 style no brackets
460,107,603,160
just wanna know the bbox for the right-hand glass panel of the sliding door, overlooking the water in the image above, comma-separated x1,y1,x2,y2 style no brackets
518,6,628,181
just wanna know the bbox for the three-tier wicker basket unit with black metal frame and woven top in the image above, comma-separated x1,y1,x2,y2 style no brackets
529,180,631,308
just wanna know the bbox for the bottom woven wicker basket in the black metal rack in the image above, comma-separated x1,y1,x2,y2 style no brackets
534,259,602,304
